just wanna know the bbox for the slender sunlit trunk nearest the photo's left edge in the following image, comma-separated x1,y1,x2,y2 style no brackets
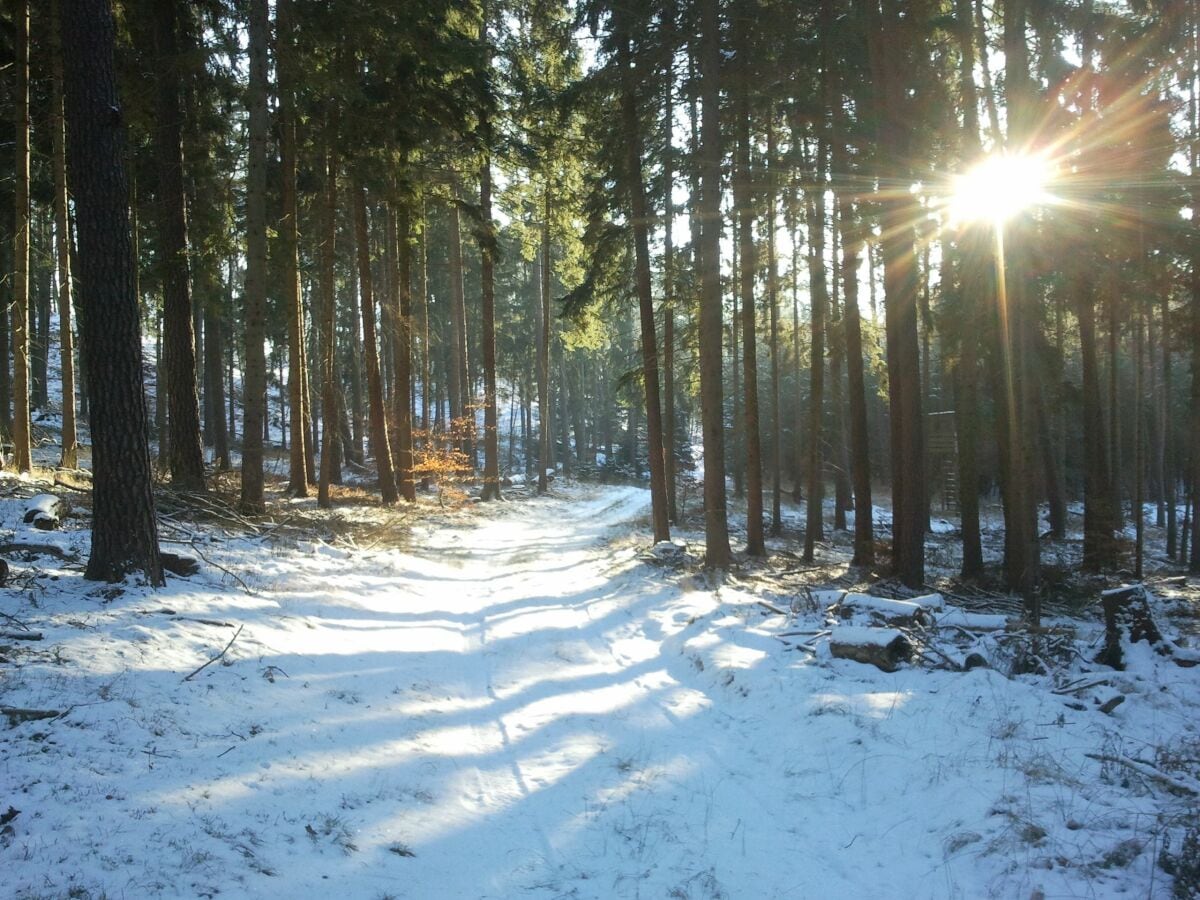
12,0,34,480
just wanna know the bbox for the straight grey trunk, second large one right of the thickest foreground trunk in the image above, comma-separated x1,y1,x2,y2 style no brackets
241,0,271,515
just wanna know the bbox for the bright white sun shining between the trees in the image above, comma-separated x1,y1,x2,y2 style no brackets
949,154,1052,224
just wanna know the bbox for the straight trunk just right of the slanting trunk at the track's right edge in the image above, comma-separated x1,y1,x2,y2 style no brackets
696,0,730,569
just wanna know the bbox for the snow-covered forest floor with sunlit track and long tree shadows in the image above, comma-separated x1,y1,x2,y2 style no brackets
0,465,1200,900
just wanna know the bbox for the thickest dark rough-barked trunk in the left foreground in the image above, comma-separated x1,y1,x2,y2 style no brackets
61,0,162,584
